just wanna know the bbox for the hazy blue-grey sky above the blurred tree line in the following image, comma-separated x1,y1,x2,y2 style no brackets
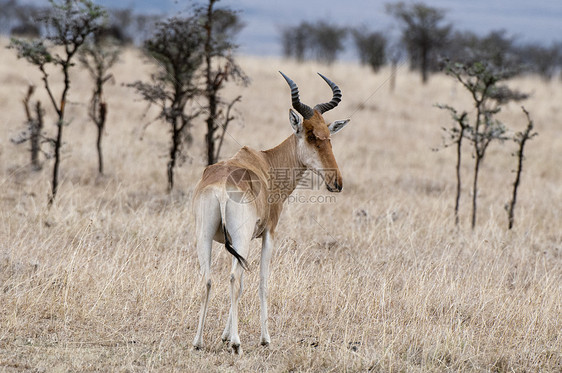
20,0,562,55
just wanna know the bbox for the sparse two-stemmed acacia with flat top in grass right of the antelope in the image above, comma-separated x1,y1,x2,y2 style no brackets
438,62,527,229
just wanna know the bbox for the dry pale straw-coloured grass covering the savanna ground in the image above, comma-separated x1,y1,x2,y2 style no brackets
0,40,562,372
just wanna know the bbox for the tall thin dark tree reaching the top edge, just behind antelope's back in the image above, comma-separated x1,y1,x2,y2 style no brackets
200,0,248,165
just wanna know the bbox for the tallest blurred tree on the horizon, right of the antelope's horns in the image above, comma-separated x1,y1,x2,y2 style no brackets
386,2,452,84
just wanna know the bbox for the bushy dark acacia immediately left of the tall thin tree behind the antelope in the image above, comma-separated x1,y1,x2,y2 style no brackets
129,17,204,191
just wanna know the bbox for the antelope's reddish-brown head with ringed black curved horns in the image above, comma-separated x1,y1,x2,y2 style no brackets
280,72,349,192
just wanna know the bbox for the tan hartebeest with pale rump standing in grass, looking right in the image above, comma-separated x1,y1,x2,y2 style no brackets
193,73,349,353
